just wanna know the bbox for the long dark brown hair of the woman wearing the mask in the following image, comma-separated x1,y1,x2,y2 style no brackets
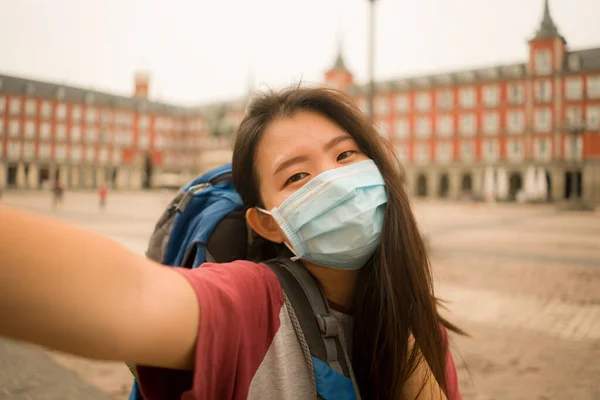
233,87,461,399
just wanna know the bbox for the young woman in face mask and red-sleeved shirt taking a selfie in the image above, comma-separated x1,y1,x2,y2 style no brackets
0,88,460,399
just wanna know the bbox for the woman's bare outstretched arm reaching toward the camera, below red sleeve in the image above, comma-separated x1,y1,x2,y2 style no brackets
0,206,199,368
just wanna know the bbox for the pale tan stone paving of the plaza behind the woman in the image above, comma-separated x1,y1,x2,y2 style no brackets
0,192,600,400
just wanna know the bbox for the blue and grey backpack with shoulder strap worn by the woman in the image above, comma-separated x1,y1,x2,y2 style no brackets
128,164,360,400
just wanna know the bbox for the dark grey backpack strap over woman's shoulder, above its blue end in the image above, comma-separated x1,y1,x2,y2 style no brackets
266,257,353,380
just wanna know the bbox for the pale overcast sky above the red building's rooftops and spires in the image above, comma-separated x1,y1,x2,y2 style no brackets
0,0,600,104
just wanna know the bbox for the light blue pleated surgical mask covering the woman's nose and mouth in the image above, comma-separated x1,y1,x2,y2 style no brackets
258,160,387,269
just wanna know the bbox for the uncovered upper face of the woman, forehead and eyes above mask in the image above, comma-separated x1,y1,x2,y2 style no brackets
256,111,368,210
